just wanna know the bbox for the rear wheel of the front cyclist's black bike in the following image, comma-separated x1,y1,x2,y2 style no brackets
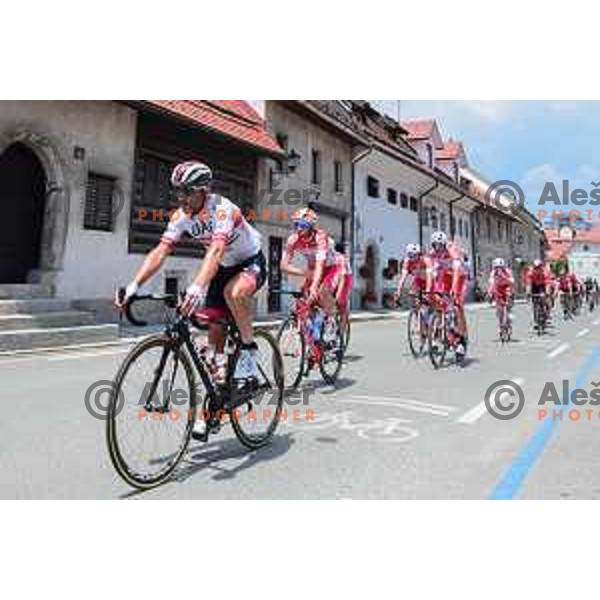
229,329,285,449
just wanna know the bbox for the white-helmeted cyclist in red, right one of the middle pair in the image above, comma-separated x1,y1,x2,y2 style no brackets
426,231,467,356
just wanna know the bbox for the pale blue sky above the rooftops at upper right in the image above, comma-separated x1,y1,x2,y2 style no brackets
373,100,600,216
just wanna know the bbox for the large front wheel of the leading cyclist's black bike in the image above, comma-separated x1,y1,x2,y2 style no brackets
106,334,196,489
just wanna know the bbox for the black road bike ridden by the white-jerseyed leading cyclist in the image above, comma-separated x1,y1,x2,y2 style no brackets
106,294,284,490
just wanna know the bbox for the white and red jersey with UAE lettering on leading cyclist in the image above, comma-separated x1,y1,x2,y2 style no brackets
160,194,261,267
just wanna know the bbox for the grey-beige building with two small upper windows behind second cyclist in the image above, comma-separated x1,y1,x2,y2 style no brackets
256,100,367,313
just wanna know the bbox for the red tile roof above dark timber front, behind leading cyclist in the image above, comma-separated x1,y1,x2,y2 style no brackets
147,100,283,154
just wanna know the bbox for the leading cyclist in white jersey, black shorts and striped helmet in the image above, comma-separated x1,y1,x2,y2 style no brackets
117,161,266,383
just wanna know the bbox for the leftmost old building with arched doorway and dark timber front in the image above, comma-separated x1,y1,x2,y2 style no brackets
0,100,282,347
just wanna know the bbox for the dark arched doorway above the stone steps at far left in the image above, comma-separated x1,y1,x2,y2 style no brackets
0,143,46,283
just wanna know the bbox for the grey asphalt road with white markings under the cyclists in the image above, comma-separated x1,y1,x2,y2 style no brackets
0,305,600,499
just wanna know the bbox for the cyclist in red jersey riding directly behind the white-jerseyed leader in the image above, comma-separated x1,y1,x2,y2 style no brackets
281,208,338,315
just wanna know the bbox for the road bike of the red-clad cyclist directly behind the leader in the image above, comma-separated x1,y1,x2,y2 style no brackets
277,291,344,389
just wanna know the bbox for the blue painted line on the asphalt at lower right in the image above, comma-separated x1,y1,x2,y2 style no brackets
488,347,600,500
